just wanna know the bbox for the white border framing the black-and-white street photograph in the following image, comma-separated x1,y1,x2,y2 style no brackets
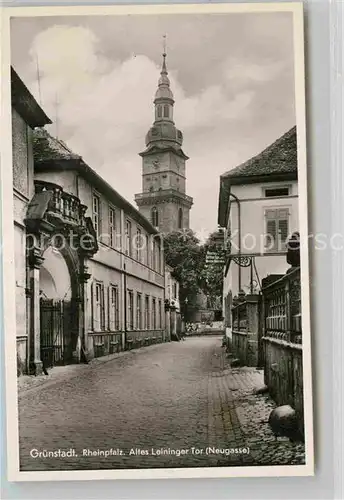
0,2,314,481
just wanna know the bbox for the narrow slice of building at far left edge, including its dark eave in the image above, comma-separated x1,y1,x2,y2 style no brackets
11,68,51,374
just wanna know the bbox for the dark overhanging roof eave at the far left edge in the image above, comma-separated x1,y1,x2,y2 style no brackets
11,66,51,128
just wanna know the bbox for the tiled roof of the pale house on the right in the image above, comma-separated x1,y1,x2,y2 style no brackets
218,126,297,227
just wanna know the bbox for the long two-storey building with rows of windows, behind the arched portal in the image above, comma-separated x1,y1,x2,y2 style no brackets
35,130,165,366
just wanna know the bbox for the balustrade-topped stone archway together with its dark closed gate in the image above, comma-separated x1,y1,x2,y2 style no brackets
25,181,98,374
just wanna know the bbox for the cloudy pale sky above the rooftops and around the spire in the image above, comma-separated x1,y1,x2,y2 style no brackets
11,12,296,240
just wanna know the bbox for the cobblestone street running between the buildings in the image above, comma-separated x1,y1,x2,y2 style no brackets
19,337,304,470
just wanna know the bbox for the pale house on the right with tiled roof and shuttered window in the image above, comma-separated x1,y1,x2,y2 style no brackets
218,127,299,334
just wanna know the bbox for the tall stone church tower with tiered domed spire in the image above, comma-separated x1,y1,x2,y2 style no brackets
135,50,193,234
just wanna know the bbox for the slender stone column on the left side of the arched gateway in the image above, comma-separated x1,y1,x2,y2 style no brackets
29,247,44,375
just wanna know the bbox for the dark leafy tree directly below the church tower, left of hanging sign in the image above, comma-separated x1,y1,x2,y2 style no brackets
164,229,204,317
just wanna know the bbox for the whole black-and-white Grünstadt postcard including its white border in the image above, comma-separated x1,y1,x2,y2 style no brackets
1,3,313,481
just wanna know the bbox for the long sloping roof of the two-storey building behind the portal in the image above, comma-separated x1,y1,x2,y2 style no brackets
33,129,158,234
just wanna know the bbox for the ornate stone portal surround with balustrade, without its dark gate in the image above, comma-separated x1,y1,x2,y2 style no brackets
25,181,98,375
